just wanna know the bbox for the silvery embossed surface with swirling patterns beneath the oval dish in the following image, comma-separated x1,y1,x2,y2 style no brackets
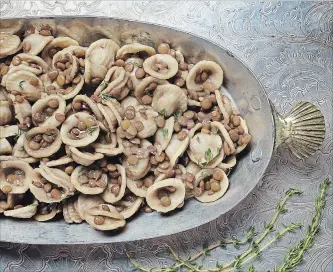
0,0,333,272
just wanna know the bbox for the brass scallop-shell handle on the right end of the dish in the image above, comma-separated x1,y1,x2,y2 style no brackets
271,101,325,158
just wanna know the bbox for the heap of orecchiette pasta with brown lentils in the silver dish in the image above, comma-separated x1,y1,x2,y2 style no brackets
0,20,251,230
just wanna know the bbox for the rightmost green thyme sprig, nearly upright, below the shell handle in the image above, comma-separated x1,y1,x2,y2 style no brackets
275,179,330,272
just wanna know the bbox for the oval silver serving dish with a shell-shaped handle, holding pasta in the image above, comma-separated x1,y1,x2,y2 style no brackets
0,17,325,244
